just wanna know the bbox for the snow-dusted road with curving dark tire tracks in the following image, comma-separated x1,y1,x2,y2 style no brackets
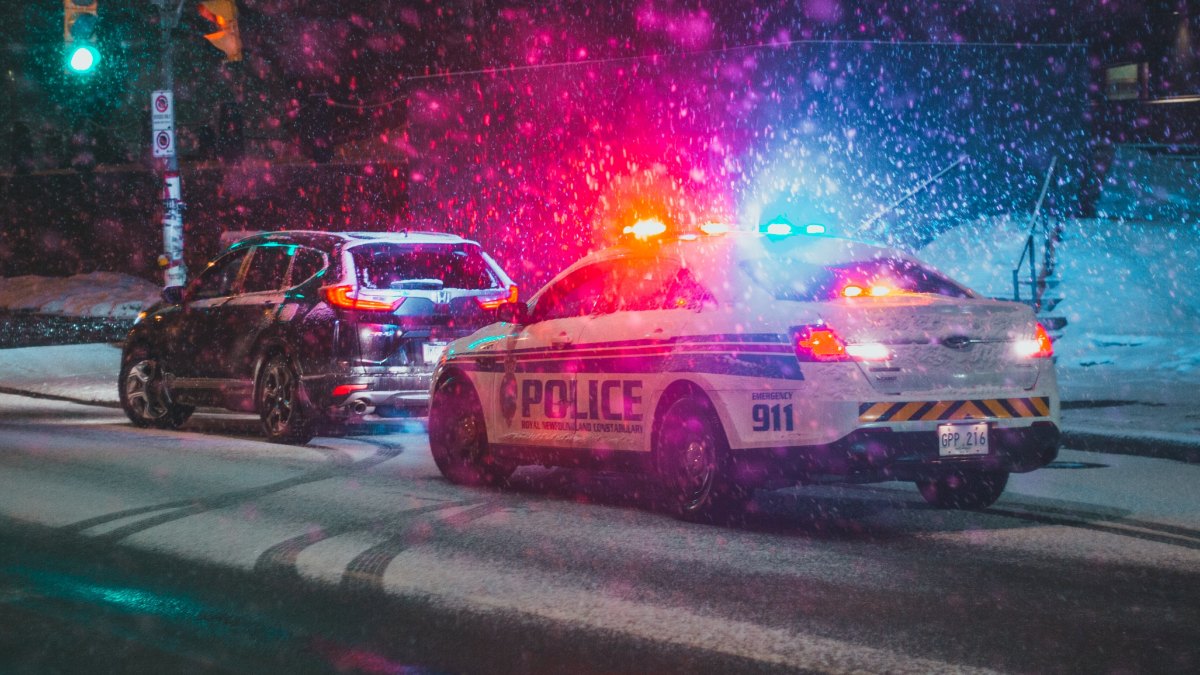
0,395,1200,673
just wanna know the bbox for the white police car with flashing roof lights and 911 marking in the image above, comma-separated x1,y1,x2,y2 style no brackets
430,223,1060,519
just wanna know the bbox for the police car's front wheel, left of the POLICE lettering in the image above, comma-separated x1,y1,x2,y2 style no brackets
430,377,514,485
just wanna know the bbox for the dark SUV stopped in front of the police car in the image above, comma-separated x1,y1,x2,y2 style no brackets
119,232,517,443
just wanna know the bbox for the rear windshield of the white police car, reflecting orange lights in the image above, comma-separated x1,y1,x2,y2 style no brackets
742,257,974,303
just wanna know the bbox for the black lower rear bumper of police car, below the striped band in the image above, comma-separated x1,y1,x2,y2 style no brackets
731,422,1060,488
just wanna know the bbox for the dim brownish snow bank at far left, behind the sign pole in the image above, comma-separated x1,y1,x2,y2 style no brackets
0,271,158,318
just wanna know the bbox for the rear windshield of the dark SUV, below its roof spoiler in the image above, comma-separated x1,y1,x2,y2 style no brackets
350,244,500,291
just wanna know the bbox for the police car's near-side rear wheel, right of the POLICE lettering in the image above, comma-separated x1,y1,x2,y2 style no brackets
655,396,750,522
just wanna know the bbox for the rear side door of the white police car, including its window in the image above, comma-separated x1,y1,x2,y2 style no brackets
575,256,696,455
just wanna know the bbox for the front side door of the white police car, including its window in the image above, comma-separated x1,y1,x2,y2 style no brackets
491,257,612,449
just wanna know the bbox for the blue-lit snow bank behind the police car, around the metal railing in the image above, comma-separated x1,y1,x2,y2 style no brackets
918,219,1200,375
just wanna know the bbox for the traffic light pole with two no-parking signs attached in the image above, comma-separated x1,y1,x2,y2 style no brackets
150,0,187,296
